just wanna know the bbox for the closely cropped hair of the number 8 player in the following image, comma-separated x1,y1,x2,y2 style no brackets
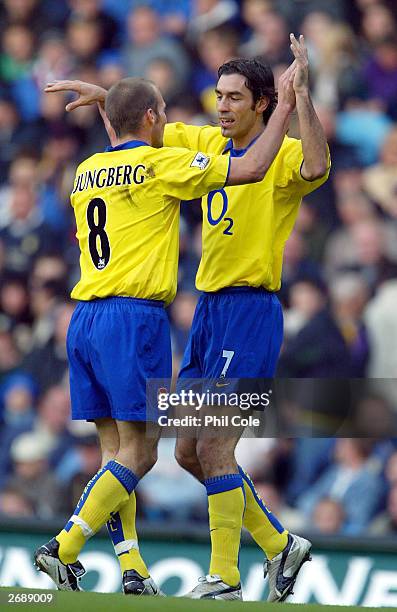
105,77,158,138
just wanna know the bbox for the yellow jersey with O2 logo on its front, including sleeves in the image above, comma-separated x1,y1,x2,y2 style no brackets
164,123,329,291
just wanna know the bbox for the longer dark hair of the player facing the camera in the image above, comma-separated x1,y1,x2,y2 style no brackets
218,58,277,125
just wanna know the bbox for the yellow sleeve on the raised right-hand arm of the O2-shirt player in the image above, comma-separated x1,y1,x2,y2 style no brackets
280,137,331,196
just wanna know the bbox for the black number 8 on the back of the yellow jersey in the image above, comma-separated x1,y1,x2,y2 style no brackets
87,198,110,270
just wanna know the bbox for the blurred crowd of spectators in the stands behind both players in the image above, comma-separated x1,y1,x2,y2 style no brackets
0,0,397,534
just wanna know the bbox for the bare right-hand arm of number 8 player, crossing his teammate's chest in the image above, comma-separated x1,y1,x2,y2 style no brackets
226,62,296,185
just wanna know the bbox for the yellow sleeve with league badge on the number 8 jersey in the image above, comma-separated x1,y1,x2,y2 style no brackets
154,147,230,200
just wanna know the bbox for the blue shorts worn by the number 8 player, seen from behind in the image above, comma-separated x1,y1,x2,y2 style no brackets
66,297,172,421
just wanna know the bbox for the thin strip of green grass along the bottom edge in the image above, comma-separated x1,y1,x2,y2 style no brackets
0,587,386,612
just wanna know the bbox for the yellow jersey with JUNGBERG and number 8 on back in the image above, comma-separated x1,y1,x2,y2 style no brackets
71,140,229,304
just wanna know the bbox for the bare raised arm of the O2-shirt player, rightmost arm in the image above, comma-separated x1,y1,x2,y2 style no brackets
290,34,329,181
